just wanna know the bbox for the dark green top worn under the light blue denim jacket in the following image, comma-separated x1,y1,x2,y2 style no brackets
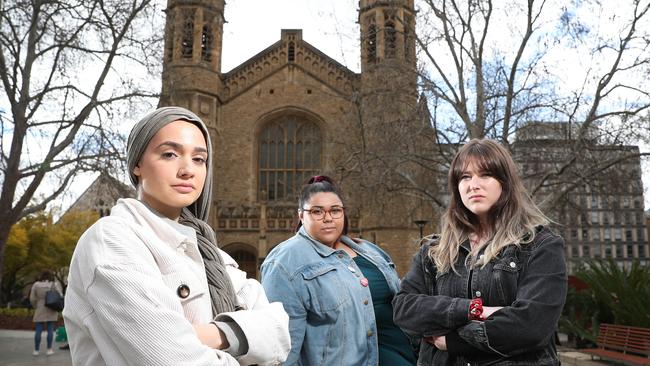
354,255,416,366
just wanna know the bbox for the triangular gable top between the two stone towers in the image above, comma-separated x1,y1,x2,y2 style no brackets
223,29,359,101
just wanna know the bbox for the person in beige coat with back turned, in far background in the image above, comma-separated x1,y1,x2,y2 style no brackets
29,271,62,356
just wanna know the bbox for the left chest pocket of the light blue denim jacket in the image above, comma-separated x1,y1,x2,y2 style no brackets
302,263,348,314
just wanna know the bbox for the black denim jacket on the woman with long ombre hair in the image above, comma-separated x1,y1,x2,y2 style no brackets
393,227,567,366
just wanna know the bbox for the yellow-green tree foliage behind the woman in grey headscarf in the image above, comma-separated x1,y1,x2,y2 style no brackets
2,211,99,303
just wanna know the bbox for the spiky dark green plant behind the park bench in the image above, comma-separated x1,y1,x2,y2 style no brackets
560,259,650,342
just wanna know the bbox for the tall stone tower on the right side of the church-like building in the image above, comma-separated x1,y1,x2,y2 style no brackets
355,0,423,242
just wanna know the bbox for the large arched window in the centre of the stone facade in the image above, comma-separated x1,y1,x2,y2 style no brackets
258,115,321,201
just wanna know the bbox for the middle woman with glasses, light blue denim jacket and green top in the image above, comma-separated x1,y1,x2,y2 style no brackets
262,176,415,366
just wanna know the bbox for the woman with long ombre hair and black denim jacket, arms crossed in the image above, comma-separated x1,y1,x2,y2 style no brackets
393,139,567,366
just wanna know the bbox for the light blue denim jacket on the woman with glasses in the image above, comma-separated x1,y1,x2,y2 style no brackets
262,227,400,366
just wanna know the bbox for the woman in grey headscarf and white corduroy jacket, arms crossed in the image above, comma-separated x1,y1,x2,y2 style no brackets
63,107,290,365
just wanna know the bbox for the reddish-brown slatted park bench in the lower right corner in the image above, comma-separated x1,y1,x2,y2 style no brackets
580,323,650,365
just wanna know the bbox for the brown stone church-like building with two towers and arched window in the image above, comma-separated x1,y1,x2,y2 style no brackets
160,0,430,275
